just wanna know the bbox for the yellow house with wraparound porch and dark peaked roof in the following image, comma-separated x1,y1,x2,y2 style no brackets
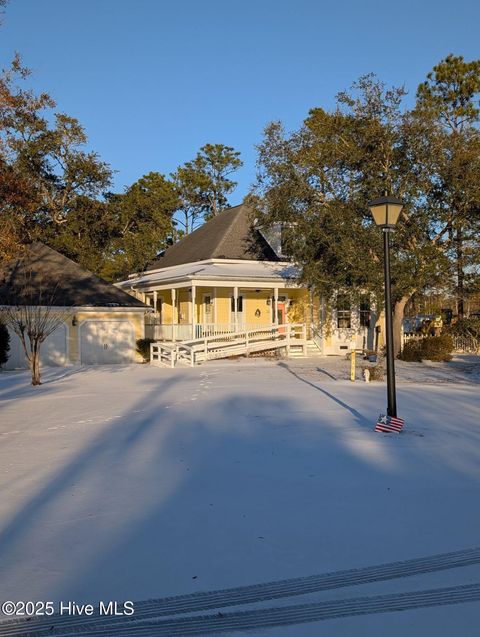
116,204,374,354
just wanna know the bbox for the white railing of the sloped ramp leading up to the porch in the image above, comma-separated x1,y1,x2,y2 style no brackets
150,323,307,367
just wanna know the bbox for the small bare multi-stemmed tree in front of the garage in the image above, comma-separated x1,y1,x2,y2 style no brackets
0,269,73,385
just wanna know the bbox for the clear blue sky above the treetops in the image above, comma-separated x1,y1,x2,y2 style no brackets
0,0,480,204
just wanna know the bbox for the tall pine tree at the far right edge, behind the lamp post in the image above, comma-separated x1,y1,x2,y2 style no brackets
415,55,480,317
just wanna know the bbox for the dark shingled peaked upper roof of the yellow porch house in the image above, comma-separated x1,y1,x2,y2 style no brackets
147,204,280,271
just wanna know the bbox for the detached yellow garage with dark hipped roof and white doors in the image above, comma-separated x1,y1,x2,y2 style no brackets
0,242,149,369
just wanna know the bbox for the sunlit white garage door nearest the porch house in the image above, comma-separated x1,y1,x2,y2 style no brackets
80,320,135,365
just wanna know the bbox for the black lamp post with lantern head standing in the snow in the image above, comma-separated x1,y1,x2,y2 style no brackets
369,197,403,418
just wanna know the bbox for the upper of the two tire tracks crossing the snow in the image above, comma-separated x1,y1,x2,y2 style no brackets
0,547,480,637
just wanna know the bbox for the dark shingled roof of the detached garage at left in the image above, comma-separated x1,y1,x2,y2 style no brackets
0,242,146,307
